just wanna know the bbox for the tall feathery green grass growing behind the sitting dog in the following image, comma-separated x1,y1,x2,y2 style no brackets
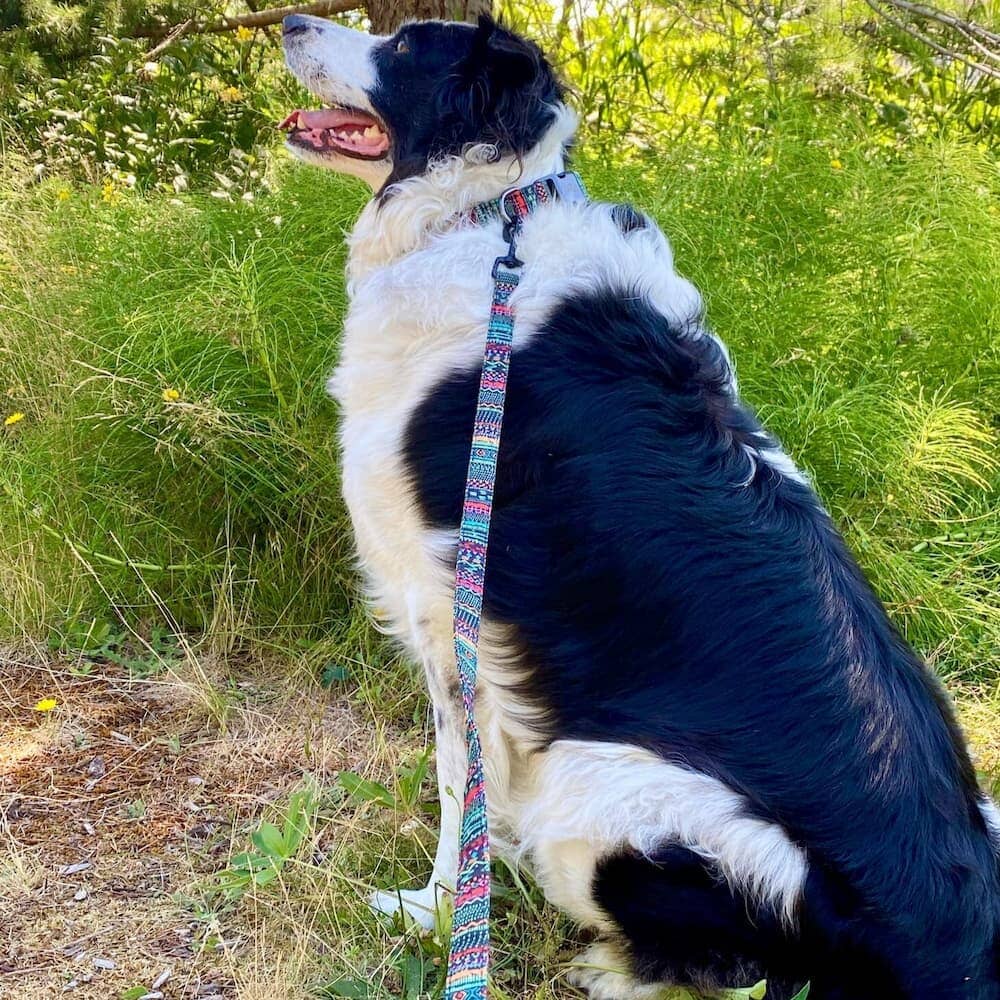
0,108,1000,997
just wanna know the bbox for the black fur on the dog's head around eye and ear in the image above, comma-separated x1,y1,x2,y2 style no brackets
368,16,562,190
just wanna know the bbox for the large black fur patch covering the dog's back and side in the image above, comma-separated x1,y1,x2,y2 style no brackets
406,288,1000,1000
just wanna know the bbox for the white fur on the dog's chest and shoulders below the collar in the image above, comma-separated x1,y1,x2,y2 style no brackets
330,204,700,688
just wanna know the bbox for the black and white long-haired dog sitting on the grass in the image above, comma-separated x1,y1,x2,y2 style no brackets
284,16,1000,1000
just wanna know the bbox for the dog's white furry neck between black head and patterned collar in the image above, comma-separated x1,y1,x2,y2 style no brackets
347,106,576,292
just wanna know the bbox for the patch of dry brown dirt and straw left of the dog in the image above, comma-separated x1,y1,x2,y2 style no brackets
0,658,370,1000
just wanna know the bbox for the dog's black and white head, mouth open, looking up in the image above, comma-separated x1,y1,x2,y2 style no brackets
282,14,562,188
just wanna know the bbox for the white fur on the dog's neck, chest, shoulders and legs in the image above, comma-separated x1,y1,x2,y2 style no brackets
284,19,806,980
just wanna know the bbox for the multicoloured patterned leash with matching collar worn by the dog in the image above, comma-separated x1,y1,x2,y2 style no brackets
442,173,587,1000
